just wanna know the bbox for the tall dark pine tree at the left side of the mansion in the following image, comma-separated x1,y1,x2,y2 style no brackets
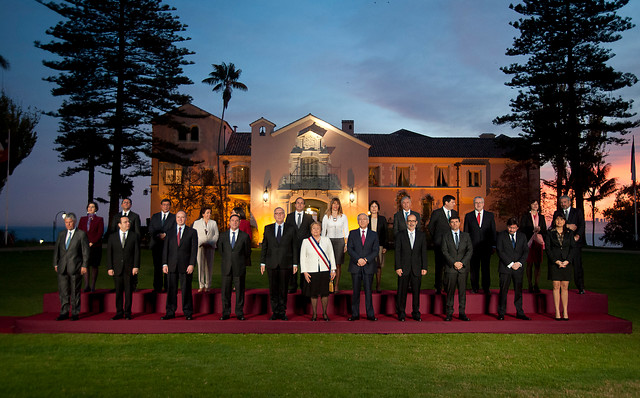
35,0,192,225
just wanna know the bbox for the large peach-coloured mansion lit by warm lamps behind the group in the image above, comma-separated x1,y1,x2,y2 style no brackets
150,104,540,242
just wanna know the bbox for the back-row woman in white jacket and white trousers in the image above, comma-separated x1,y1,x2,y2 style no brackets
193,207,219,293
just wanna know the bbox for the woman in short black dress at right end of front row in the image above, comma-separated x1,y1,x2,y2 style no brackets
545,213,576,321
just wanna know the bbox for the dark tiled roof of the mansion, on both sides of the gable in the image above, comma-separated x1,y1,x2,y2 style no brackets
225,129,507,158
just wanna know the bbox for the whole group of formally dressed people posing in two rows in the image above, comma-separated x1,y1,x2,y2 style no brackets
54,195,584,321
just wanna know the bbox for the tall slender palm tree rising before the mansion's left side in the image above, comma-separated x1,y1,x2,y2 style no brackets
202,62,247,225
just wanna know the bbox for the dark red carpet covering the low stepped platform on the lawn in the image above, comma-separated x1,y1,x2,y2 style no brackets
0,289,632,334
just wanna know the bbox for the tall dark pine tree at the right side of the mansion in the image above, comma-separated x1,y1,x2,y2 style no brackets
494,0,637,209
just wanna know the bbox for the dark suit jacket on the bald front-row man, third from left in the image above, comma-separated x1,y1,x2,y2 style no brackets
162,225,198,274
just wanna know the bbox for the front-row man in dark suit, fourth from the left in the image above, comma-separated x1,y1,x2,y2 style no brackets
218,214,251,321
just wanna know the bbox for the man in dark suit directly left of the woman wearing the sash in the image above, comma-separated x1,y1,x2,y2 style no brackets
260,207,300,321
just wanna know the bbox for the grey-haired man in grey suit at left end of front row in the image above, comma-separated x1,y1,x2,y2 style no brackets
53,213,89,321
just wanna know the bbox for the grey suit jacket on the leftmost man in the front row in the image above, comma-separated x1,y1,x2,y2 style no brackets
53,228,89,274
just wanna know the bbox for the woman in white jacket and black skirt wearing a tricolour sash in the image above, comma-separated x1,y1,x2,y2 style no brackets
300,221,336,321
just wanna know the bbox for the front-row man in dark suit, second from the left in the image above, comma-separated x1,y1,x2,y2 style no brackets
107,216,140,320
